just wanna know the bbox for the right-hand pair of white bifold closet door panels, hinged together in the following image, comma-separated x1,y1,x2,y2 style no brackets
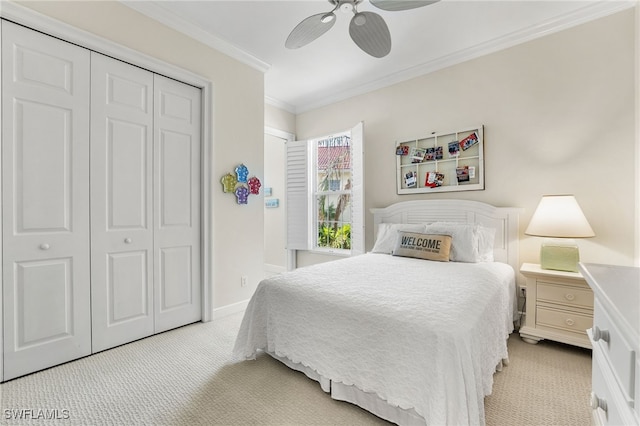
91,53,201,352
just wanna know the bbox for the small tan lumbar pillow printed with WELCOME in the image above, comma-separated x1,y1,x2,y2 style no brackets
393,231,451,262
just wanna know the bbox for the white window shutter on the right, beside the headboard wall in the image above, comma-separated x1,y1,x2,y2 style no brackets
351,122,365,256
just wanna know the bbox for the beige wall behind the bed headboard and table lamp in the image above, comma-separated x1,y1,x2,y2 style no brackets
296,10,639,265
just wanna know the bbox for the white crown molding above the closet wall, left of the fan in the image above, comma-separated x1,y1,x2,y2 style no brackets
119,0,271,73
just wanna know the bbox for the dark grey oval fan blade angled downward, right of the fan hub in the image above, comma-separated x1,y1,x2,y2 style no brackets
349,12,391,58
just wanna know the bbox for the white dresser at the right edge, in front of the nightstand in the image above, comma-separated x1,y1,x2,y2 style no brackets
580,263,640,425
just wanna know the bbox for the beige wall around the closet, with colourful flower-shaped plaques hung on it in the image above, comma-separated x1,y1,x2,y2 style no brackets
16,2,264,309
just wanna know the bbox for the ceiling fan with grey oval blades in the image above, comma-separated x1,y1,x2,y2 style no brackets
284,0,439,58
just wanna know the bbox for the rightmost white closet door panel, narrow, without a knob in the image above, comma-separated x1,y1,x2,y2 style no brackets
154,75,201,333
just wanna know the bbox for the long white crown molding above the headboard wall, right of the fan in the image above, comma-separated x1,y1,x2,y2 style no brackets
295,0,640,114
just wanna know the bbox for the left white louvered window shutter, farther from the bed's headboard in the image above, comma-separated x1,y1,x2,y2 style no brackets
286,141,310,250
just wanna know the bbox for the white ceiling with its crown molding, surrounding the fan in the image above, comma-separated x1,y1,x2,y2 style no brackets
124,0,635,113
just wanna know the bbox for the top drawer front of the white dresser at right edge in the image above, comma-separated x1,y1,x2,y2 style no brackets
591,301,636,406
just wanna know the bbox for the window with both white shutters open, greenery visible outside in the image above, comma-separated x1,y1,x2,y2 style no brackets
286,123,364,254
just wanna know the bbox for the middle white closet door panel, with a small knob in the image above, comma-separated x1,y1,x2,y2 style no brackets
91,53,154,352
